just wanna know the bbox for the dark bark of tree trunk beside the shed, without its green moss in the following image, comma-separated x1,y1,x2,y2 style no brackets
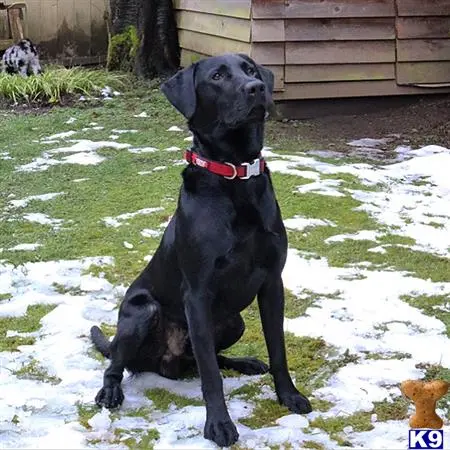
110,0,180,78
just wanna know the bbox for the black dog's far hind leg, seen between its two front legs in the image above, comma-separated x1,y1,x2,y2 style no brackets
216,314,269,375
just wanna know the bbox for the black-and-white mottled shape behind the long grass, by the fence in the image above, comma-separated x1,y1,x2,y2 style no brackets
0,39,42,77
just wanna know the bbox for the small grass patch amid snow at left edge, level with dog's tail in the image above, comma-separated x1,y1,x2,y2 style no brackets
0,305,55,352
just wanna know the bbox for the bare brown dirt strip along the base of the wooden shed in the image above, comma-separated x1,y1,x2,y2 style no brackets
269,95,450,150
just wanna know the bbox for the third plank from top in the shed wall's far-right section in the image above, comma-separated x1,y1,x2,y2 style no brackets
397,39,450,62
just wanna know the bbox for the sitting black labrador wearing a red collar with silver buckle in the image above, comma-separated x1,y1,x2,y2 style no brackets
91,54,311,446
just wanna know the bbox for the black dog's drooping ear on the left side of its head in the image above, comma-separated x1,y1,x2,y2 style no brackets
161,64,197,120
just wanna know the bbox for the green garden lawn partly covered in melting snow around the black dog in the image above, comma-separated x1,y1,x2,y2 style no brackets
0,78,450,449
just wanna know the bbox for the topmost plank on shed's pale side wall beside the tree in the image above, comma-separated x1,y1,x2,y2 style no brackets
174,0,252,19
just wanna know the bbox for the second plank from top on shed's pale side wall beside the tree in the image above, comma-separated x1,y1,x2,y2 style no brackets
175,10,250,42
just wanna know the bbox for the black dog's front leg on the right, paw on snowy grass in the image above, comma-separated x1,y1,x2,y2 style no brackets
258,275,312,414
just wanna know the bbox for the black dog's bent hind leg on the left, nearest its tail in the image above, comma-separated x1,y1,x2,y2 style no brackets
91,289,160,408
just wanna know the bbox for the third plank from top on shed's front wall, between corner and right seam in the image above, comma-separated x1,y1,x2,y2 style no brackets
286,41,395,64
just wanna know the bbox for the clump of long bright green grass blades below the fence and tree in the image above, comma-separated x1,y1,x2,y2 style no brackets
0,66,124,104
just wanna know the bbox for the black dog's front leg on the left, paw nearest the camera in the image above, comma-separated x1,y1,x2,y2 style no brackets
185,286,239,447
